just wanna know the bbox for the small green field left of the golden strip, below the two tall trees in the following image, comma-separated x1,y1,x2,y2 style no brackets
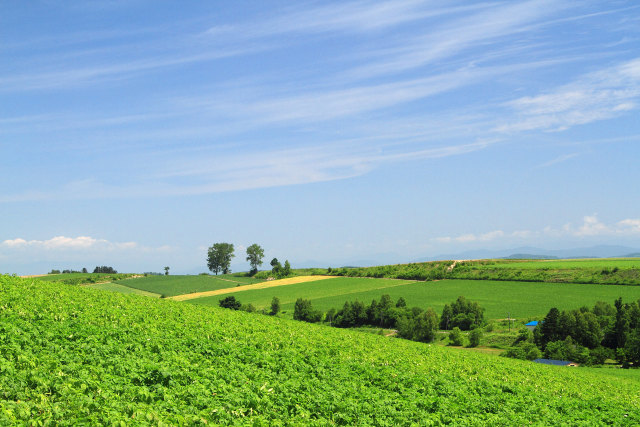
115,275,260,296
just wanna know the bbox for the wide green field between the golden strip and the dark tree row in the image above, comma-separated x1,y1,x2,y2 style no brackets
189,277,640,319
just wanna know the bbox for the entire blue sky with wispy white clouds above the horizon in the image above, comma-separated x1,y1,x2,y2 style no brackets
0,0,640,274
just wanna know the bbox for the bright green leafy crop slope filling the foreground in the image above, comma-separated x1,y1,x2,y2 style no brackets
0,276,640,425
